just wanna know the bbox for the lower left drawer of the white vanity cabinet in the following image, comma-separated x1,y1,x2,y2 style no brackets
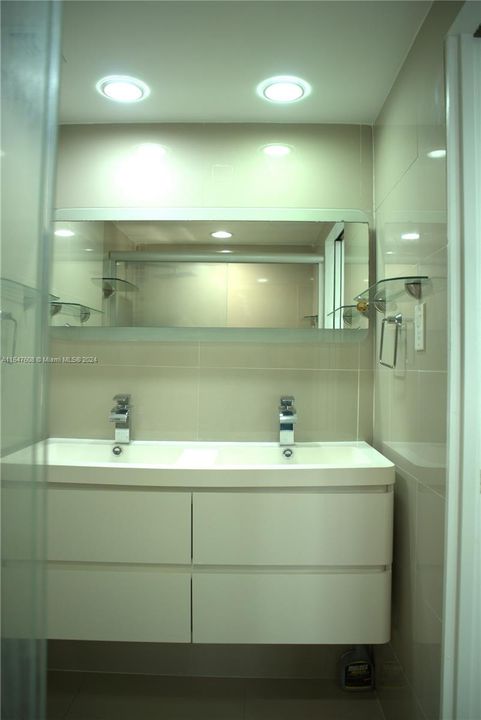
47,566,190,642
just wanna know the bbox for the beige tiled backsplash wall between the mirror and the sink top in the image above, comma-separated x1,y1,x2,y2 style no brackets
50,339,372,441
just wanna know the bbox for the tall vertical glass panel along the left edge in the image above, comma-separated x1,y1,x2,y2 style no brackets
0,2,60,720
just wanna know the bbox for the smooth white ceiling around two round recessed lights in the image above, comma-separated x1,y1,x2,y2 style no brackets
60,0,431,124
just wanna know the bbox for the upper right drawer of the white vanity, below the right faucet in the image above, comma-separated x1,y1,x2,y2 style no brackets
193,492,393,565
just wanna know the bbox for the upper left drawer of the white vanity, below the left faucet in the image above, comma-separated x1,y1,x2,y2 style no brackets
47,487,191,564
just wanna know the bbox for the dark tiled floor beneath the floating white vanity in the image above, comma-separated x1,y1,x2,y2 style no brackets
47,672,384,720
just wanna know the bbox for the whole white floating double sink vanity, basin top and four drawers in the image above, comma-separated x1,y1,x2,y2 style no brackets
29,439,394,644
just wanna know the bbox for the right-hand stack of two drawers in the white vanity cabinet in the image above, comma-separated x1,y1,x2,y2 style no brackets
192,486,393,644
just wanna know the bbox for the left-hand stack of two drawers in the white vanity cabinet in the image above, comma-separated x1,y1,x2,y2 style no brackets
47,485,191,642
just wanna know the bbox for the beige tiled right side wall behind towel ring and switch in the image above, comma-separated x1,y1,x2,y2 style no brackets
374,2,461,720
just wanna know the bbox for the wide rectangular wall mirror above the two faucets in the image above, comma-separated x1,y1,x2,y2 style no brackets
50,210,369,341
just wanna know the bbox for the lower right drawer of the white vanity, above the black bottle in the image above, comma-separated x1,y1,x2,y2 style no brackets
192,571,391,644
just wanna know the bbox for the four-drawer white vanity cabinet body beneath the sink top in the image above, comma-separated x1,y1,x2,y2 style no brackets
48,473,393,644
